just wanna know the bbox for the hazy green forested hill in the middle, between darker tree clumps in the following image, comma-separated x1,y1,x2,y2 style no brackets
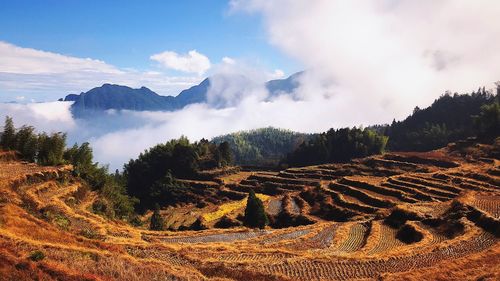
212,127,312,166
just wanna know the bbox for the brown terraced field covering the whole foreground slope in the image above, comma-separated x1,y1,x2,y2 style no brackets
0,143,500,280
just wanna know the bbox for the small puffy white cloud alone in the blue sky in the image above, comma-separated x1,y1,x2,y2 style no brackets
150,50,210,75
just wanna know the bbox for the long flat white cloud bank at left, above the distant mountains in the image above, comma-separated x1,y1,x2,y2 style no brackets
0,41,200,101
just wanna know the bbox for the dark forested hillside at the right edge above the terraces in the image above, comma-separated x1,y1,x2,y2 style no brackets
384,85,500,151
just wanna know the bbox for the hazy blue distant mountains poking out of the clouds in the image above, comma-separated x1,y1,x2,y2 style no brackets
64,72,302,117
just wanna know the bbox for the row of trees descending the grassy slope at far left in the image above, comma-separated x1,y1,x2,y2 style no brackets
0,116,137,219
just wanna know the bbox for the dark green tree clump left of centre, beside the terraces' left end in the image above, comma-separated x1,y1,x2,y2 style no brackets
123,137,232,212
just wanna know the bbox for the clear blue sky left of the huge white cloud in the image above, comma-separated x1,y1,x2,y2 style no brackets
0,0,301,101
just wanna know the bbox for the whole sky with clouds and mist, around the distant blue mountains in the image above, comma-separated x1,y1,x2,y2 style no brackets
0,0,500,168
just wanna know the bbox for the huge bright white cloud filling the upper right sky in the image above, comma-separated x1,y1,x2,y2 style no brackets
231,0,500,122
